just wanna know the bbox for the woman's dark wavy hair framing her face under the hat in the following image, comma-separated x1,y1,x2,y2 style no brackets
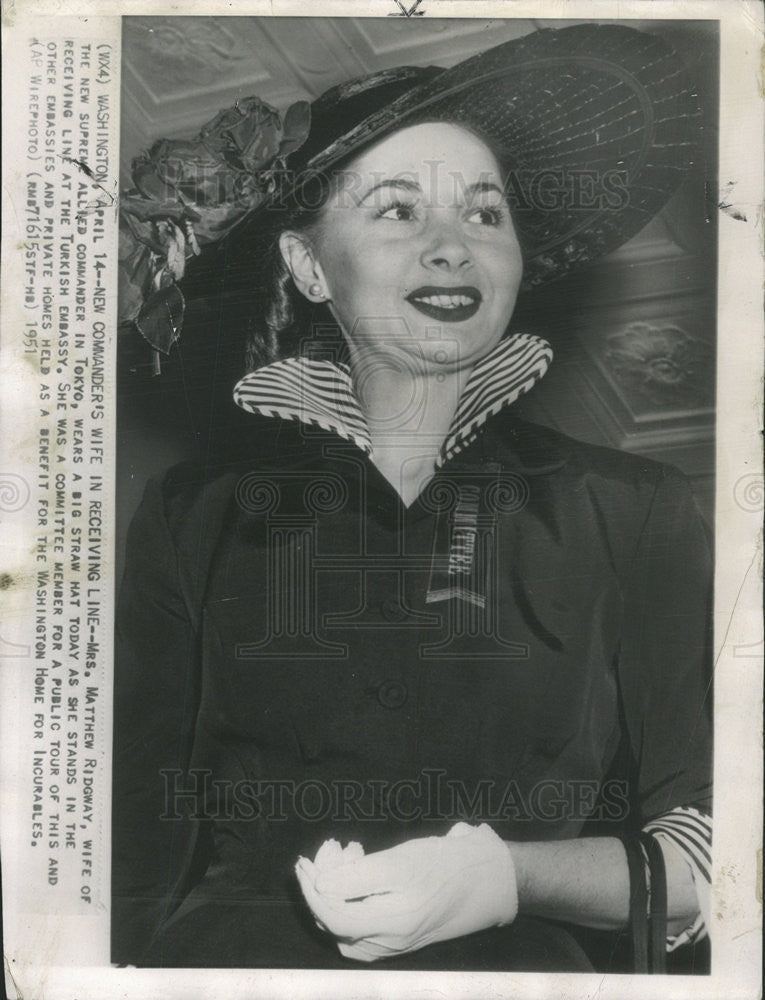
245,119,515,371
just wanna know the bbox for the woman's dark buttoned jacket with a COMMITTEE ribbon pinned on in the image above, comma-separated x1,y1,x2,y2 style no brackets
113,410,711,965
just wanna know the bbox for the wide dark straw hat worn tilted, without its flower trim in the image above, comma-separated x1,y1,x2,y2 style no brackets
219,24,701,289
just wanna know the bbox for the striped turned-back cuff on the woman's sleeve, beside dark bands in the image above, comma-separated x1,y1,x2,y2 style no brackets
643,806,712,951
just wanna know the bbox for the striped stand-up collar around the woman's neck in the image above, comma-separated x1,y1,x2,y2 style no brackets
234,333,552,468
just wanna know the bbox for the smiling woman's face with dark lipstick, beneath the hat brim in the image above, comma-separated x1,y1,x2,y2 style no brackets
314,124,523,371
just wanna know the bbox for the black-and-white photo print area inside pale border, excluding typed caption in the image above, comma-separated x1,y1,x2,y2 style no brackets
112,11,717,974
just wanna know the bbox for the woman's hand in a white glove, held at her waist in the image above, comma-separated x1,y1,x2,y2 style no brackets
295,823,518,962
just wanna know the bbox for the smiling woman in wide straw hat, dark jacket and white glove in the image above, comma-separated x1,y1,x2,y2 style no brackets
114,26,709,971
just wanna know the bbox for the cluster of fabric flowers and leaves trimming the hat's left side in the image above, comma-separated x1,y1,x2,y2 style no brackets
119,97,311,366
